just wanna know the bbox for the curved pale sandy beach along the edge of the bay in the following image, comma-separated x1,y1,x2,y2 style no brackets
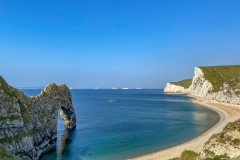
129,100,240,160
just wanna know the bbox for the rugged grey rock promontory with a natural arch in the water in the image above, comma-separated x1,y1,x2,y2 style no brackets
0,77,76,159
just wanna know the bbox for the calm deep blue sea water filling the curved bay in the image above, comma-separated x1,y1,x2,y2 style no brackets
22,89,219,160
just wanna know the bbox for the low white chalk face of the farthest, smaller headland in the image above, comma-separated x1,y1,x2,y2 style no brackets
164,82,191,94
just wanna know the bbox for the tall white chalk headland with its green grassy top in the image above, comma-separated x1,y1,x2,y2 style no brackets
190,66,240,105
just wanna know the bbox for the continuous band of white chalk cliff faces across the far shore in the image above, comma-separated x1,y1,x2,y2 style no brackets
164,67,240,105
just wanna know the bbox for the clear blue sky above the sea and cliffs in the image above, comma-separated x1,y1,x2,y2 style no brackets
0,0,240,88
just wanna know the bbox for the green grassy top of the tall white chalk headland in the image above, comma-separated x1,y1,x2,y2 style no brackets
199,65,240,92
